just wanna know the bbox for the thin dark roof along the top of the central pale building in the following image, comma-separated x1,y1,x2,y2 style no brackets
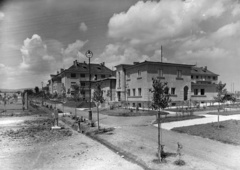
118,60,195,69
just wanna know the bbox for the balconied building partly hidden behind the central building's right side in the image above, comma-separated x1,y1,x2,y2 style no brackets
191,67,219,101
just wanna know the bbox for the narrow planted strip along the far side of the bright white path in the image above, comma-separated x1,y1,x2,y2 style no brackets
153,115,205,124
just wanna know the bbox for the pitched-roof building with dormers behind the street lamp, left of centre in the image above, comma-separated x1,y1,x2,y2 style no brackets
49,60,113,99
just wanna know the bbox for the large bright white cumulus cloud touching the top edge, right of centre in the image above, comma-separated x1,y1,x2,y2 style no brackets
108,0,229,44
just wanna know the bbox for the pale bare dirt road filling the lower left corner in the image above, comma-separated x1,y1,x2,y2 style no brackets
0,117,142,170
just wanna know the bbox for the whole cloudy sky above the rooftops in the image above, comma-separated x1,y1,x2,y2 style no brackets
0,0,240,90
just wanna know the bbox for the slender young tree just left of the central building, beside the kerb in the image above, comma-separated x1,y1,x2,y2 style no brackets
93,83,105,130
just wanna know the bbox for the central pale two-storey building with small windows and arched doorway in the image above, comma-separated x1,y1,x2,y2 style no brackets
116,61,193,107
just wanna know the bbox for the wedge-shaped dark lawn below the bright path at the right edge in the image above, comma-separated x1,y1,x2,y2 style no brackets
172,120,240,145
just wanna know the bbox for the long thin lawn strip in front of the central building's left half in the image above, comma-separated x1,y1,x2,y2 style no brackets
101,108,169,116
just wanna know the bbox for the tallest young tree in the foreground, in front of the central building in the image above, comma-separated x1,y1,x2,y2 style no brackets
151,78,171,162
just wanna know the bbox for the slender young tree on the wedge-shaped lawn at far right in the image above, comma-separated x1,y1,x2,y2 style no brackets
214,81,227,128
